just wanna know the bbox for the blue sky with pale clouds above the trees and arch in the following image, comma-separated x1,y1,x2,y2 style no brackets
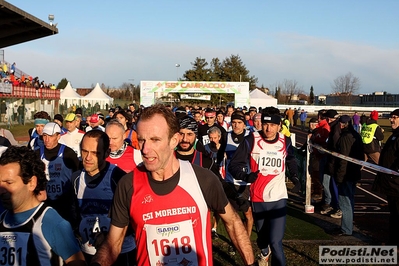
4,0,399,95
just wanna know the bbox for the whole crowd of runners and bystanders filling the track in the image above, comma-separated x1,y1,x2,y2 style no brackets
0,104,399,265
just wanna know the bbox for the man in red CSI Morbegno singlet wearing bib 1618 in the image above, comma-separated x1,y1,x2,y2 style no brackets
93,104,254,265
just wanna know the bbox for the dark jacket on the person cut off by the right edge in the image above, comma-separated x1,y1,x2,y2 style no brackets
373,128,399,197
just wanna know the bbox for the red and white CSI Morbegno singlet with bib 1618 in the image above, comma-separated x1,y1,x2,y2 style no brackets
130,160,213,265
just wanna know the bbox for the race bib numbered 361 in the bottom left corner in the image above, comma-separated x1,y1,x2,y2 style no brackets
0,232,30,266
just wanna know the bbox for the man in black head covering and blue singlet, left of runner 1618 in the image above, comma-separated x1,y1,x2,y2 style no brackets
72,130,136,266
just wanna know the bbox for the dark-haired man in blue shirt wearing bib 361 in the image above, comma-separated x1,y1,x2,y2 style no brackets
0,146,86,266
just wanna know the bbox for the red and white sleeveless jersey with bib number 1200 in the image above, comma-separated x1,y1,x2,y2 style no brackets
250,132,288,202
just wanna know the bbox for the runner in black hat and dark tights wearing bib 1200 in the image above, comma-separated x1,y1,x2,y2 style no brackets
228,107,298,265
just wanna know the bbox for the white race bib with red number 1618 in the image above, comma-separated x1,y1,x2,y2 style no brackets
144,220,198,266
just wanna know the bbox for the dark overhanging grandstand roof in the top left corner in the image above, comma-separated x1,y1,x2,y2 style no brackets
0,0,58,48
